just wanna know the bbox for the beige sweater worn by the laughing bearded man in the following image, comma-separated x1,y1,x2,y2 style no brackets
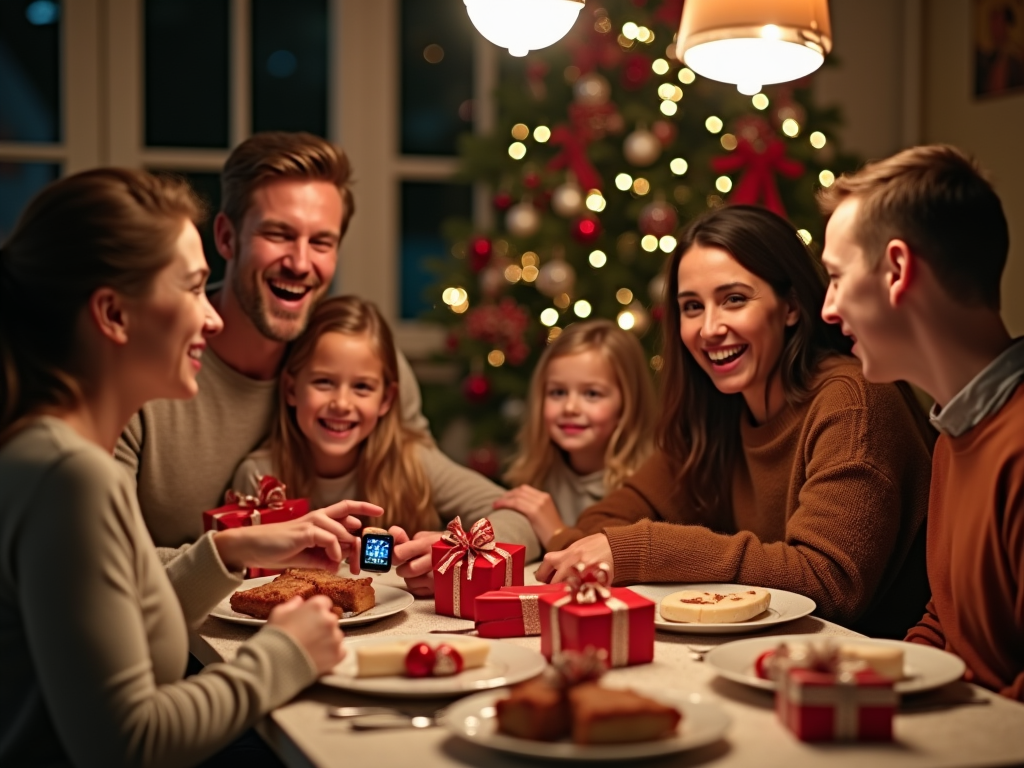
115,348,427,547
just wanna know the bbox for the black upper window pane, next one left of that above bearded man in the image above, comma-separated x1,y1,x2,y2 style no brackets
144,0,230,147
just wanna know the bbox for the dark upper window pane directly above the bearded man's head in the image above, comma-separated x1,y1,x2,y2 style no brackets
252,0,328,136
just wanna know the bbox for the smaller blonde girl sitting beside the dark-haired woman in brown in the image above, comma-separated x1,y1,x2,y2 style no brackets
495,319,654,547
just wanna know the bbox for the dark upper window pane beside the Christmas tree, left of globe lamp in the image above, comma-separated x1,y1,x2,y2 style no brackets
400,0,479,155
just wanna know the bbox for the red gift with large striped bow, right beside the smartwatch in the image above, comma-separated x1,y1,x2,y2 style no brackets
430,517,526,618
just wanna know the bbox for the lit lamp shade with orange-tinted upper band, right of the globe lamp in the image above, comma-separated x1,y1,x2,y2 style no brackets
676,0,831,93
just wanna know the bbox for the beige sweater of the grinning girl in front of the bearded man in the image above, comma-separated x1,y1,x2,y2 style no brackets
231,445,541,562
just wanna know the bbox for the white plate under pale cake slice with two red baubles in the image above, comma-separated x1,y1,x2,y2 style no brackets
319,634,548,698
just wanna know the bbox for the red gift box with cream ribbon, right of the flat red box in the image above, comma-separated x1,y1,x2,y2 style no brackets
539,563,654,667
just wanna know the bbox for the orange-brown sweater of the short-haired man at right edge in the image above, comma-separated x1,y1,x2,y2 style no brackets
906,384,1024,701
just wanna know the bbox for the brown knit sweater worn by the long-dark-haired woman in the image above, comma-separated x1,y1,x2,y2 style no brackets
551,357,934,637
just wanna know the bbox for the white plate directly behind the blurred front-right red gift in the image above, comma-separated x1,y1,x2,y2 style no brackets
705,635,967,693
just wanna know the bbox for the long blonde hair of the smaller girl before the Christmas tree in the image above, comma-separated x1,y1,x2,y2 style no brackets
505,319,654,493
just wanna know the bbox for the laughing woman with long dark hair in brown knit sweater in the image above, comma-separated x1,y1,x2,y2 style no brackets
538,206,934,637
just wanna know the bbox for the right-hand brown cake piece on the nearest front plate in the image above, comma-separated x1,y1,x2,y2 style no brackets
568,683,682,744
